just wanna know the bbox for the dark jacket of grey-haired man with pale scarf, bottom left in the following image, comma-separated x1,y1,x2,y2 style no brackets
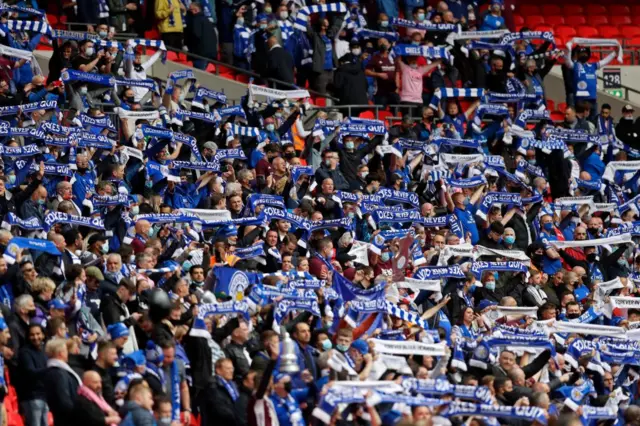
43,367,79,426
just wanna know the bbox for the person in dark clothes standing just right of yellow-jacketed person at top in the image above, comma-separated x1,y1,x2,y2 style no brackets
184,1,218,70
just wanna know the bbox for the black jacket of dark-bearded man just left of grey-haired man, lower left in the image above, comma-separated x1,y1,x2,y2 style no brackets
14,343,47,401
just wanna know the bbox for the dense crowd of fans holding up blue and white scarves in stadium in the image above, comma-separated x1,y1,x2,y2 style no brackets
0,0,640,426
